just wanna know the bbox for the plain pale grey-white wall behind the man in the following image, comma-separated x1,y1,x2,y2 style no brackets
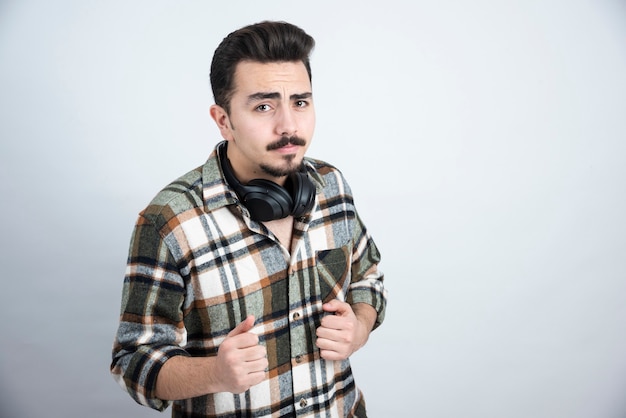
0,0,626,418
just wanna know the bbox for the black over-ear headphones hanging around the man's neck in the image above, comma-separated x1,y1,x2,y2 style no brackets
217,141,315,222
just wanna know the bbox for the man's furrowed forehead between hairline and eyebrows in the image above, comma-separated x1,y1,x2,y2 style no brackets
234,61,311,95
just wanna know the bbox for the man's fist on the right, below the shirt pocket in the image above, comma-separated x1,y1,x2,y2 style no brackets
316,299,376,360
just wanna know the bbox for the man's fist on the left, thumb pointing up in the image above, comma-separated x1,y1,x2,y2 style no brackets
215,315,268,393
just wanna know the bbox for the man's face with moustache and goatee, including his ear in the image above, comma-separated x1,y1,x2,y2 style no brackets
211,61,315,184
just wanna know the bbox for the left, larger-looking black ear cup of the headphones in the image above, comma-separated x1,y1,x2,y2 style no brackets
241,179,293,222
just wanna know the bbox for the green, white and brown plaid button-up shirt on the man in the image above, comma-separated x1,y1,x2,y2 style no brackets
111,142,386,417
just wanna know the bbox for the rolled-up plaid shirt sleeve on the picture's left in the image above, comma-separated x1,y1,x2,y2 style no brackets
111,216,189,411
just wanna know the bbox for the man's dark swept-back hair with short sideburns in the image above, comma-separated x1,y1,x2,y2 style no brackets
210,21,315,112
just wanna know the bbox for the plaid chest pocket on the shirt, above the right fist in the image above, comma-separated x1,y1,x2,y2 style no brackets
315,247,350,303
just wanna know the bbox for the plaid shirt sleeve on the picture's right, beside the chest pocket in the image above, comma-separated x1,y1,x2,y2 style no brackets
347,215,387,329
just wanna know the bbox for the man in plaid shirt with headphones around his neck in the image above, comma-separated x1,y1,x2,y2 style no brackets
111,22,386,417
